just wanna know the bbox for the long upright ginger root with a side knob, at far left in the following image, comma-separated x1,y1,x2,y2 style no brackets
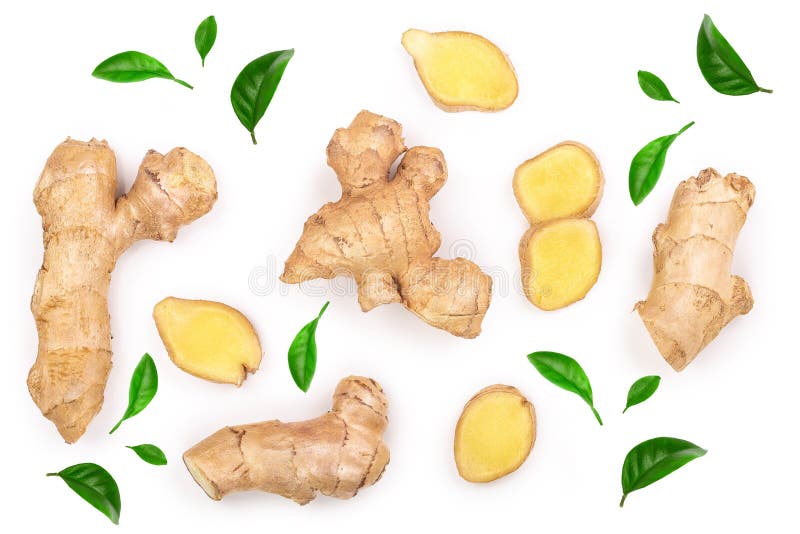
28,139,217,443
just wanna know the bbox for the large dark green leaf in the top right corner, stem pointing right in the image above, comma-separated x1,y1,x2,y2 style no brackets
697,15,772,96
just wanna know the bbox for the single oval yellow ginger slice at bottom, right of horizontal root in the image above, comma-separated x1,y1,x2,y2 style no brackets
453,385,536,482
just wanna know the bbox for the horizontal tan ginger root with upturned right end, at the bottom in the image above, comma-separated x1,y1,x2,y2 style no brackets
183,376,389,504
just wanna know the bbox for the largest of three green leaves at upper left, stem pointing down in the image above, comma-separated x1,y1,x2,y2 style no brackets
231,49,294,145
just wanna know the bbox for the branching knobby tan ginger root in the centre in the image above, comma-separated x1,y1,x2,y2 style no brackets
281,111,492,338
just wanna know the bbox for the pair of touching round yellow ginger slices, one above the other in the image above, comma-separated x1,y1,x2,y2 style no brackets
513,141,603,310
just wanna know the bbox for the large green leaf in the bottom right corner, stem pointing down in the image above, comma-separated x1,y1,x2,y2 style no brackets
619,438,707,508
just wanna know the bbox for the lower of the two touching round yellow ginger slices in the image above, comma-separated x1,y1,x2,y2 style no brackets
520,219,603,310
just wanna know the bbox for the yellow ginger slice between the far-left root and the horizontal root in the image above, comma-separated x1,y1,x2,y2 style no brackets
153,297,262,386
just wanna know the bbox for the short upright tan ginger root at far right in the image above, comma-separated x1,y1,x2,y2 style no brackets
636,169,755,371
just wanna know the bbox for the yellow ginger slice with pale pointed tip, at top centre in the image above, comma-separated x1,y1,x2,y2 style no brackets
402,29,519,111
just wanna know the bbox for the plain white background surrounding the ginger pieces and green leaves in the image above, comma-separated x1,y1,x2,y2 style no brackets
0,0,800,533
